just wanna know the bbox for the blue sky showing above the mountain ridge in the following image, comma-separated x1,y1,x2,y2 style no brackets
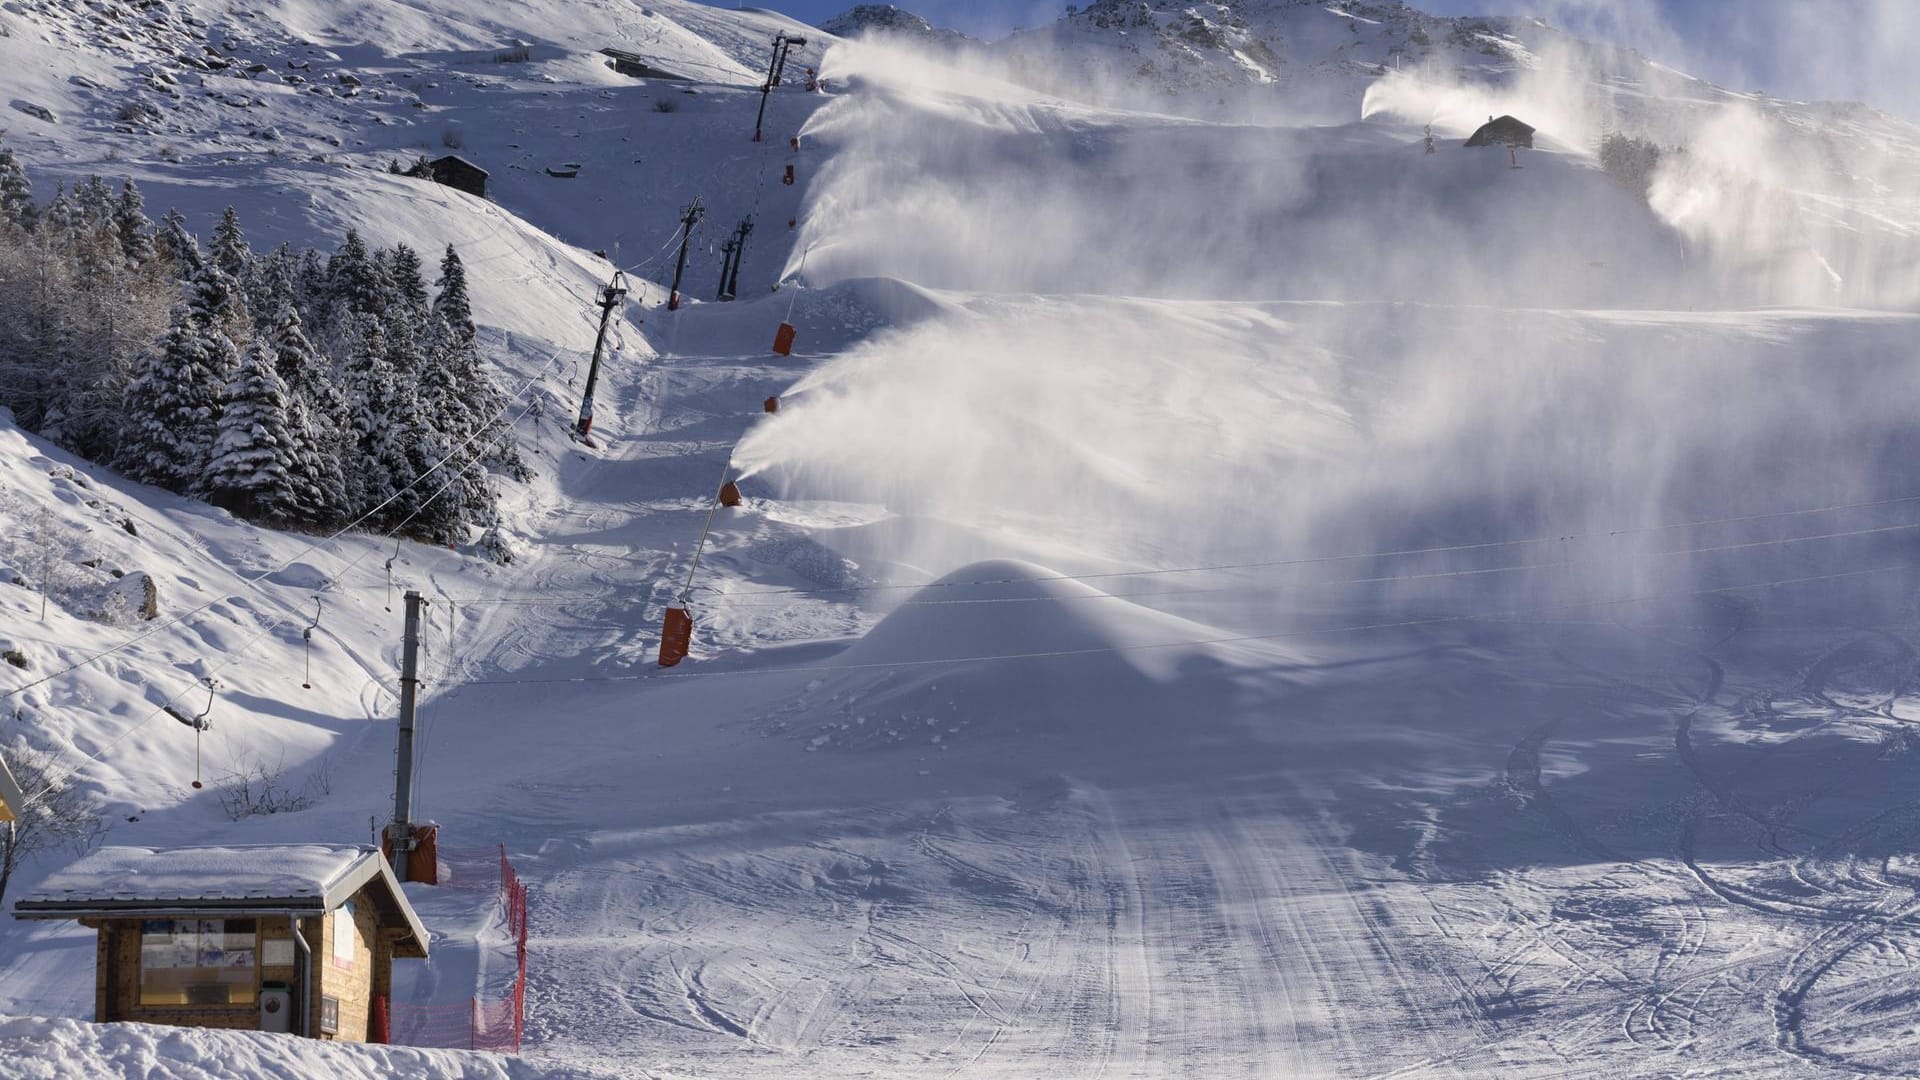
718,0,1920,119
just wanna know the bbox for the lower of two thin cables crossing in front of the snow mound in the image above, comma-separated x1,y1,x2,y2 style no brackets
439,563,1910,686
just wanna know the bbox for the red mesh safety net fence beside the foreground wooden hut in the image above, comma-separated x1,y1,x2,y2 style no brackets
374,846,526,1053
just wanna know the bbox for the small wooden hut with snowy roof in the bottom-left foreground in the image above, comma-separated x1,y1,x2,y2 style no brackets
13,844,426,1042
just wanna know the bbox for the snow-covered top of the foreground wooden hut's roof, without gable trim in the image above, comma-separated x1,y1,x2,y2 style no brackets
21,844,372,905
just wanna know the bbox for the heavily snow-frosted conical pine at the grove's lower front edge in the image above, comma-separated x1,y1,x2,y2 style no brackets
196,342,303,525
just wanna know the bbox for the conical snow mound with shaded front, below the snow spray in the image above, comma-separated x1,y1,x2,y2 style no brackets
768,561,1271,751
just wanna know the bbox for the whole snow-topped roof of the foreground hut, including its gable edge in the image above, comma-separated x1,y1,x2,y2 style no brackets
13,844,426,957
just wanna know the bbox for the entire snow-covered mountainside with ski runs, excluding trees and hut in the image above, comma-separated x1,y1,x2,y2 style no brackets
0,0,1920,1076
